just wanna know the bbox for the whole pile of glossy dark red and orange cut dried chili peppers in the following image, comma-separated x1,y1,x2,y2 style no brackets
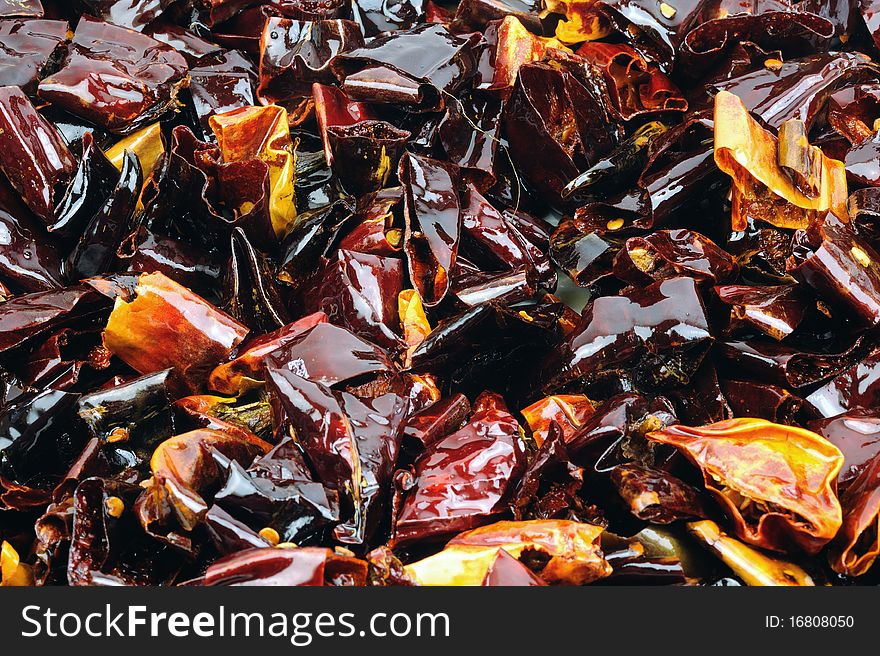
0,0,880,586
